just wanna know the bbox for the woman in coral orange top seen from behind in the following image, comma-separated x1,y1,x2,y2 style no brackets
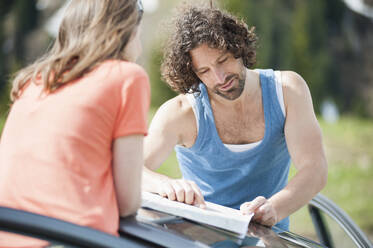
0,0,150,247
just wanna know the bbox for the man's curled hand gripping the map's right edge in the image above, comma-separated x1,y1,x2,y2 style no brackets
240,196,277,226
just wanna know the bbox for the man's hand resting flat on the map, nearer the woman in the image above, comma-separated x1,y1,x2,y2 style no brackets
157,179,206,208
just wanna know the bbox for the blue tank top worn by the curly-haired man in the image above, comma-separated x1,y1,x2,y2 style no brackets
175,69,290,230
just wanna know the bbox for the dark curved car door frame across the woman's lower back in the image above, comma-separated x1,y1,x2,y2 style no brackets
0,207,155,248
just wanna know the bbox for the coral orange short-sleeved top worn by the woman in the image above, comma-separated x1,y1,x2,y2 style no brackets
0,60,150,247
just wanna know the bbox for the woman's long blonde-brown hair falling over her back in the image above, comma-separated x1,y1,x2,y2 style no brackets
11,0,141,101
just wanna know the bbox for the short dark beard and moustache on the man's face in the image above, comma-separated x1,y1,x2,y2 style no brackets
213,69,246,101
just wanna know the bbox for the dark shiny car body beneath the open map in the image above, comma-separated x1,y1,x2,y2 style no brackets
0,195,373,248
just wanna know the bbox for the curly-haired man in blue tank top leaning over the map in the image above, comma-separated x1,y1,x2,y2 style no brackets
143,4,327,230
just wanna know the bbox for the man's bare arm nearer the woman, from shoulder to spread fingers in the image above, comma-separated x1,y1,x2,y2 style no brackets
143,95,204,206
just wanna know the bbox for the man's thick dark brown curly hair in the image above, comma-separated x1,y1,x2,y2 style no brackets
161,6,257,94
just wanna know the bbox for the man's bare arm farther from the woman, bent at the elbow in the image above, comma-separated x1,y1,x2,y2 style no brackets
241,71,327,226
